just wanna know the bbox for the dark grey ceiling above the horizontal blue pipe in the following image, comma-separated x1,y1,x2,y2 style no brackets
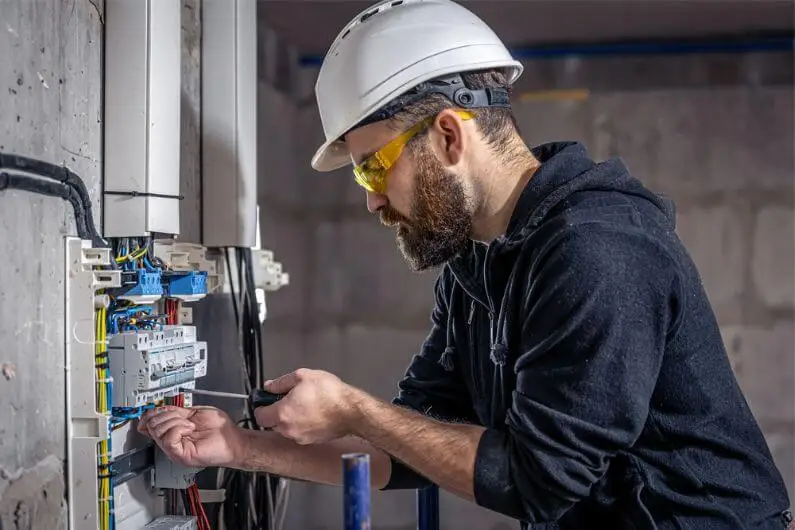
258,0,795,55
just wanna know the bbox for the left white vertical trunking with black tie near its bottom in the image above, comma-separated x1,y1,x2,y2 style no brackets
103,0,182,237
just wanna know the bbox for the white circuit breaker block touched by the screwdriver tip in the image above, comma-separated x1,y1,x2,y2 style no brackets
108,326,207,408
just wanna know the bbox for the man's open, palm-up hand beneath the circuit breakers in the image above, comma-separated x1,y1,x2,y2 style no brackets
138,406,243,467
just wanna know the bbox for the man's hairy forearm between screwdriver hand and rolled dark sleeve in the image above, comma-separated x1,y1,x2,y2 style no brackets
353,391,485,501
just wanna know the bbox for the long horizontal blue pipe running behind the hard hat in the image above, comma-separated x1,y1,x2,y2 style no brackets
298,34,795,68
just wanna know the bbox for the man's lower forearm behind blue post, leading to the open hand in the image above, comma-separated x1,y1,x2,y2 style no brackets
230,429,392,489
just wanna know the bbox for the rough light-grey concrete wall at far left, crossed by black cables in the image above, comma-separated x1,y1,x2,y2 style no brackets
0,0,103,520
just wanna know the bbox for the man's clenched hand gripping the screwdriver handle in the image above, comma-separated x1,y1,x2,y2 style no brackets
254,368,356,445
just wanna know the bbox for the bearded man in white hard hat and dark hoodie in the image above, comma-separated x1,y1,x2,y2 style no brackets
140,0,791,530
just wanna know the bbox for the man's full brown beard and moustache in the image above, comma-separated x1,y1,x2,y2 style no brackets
380,145,472,271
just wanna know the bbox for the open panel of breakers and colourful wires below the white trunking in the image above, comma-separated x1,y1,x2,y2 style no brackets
66,237,215,530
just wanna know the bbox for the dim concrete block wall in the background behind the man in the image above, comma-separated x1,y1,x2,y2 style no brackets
260,54,795,530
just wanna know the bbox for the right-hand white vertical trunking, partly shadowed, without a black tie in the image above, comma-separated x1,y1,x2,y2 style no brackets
201,0,257,247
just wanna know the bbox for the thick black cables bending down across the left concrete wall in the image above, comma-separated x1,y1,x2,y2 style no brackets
0,153,108,248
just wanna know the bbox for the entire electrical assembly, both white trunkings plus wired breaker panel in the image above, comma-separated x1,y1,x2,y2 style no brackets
64,0,296,530
